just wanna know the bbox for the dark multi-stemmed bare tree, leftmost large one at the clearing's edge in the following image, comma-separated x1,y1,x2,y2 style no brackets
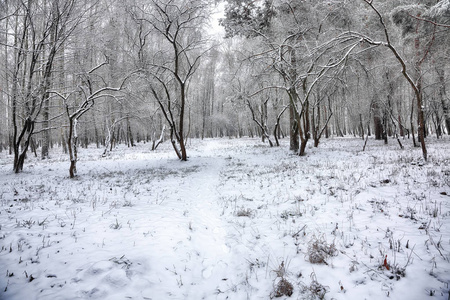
5,0,80,173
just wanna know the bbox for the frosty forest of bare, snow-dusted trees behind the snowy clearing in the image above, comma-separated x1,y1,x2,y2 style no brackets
0,0,450,173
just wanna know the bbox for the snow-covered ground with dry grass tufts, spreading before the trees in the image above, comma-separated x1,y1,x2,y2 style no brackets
0,138,450,300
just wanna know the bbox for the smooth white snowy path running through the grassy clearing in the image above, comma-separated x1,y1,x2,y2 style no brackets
142,157,236,299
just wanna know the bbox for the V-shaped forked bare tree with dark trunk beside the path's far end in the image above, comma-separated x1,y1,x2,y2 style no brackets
134,0,208,161
